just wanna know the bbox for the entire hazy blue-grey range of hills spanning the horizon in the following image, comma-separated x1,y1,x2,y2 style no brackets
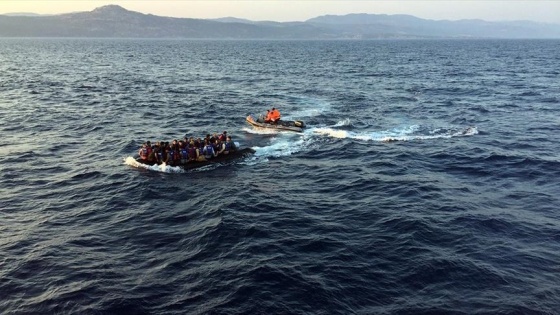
0,5,560,39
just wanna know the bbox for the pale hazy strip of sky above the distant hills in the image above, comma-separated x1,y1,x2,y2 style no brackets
0,0,560,24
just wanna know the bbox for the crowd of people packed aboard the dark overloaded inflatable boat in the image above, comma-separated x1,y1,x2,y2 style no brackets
138,131,237,166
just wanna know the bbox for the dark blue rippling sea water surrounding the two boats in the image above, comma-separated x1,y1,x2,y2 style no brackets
0,39,560,314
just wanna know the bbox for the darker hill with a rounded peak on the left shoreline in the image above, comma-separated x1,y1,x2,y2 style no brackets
0,5,328,39
